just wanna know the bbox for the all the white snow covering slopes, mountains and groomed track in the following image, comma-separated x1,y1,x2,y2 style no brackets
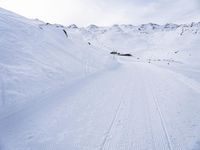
0,8,200,150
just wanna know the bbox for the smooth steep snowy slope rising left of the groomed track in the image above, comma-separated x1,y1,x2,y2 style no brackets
0,9,107,109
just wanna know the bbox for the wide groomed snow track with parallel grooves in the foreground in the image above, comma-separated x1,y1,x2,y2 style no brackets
0,61,200,150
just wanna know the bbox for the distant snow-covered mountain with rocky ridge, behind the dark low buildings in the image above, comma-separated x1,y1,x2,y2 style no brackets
68,22,200,64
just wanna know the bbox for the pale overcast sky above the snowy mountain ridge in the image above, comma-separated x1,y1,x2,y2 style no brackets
0,0,200,26
